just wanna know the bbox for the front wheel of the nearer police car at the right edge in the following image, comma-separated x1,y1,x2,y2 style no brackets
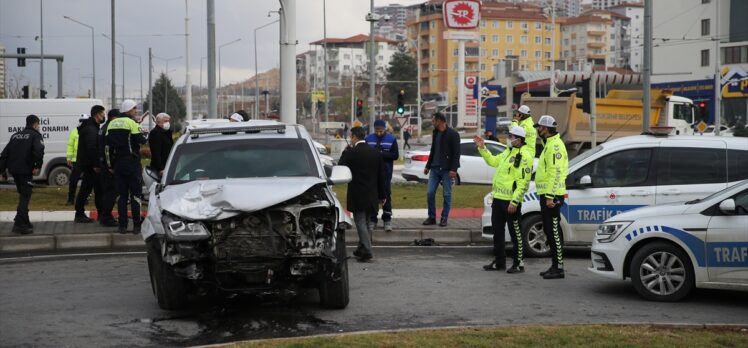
629,242,694,302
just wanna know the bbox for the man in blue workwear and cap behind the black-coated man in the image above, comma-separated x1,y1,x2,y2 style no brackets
366,120,400,232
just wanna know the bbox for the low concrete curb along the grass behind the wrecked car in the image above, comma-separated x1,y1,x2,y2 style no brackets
0,229,491,255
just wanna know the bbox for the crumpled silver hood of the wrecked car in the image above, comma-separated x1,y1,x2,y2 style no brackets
159,177,325,220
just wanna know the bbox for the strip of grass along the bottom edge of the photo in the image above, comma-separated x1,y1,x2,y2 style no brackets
231,325,748,348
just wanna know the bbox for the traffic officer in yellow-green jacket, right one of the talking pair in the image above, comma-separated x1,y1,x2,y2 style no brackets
535,115,569,279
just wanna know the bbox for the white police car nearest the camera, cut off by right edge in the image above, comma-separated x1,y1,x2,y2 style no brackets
589,179,748,301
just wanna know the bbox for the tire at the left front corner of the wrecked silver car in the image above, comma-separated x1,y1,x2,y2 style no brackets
148,238,187,310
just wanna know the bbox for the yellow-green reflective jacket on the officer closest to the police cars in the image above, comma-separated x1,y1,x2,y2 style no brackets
535,134,569,198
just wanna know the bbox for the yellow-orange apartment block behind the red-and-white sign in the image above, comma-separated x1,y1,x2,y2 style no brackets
408,1,561,103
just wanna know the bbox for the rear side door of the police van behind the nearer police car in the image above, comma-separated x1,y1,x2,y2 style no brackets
655,140,727,205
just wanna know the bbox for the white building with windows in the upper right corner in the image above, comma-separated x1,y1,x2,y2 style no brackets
652,0,748,126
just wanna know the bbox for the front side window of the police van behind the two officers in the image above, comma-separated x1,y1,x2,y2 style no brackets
572,149,653,188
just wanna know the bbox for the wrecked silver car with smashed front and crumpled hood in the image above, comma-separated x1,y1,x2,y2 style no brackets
142,121,351,310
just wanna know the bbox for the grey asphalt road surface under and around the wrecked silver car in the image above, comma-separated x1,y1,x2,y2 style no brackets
0,247,748,347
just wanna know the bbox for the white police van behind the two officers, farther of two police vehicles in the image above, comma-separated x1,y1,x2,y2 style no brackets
481,135,748,257
